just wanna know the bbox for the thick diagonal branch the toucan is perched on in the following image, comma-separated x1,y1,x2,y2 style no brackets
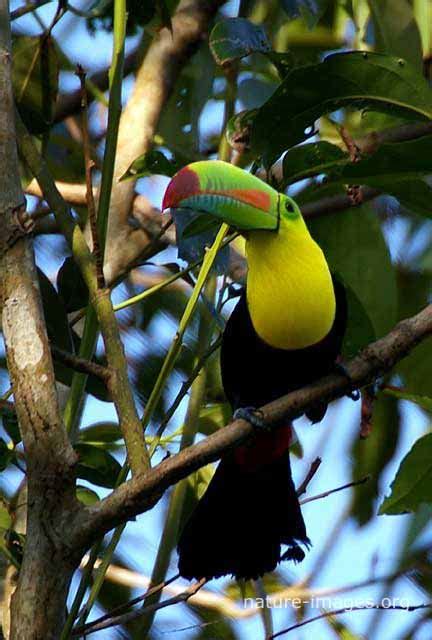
71,305,432,546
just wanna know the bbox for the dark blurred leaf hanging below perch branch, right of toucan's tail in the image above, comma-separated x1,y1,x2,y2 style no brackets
351,395,400,526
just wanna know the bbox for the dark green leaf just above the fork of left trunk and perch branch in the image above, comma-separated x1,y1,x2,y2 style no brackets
74,442,121,489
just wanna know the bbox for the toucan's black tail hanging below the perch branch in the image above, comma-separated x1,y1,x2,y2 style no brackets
178,427,309,579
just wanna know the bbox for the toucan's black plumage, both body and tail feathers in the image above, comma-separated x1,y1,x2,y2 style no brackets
178,279,347,579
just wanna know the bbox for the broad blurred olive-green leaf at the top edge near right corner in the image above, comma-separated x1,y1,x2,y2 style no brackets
368,0,423,71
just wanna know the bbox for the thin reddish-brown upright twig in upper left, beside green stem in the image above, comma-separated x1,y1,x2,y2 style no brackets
75,64,105,289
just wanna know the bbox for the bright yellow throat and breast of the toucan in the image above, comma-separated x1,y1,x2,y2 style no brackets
246,216,336,349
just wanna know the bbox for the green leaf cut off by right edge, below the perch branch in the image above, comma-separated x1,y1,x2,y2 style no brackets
379,433,432,515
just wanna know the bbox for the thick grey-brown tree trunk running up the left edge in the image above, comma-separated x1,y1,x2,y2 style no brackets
0,5,81,640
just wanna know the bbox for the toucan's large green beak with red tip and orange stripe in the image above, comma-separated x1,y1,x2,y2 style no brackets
162,160,279,231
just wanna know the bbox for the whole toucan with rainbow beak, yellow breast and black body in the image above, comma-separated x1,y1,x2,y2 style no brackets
163,160,347,580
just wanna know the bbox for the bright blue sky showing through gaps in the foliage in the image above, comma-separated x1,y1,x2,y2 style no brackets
4,2,432,640
